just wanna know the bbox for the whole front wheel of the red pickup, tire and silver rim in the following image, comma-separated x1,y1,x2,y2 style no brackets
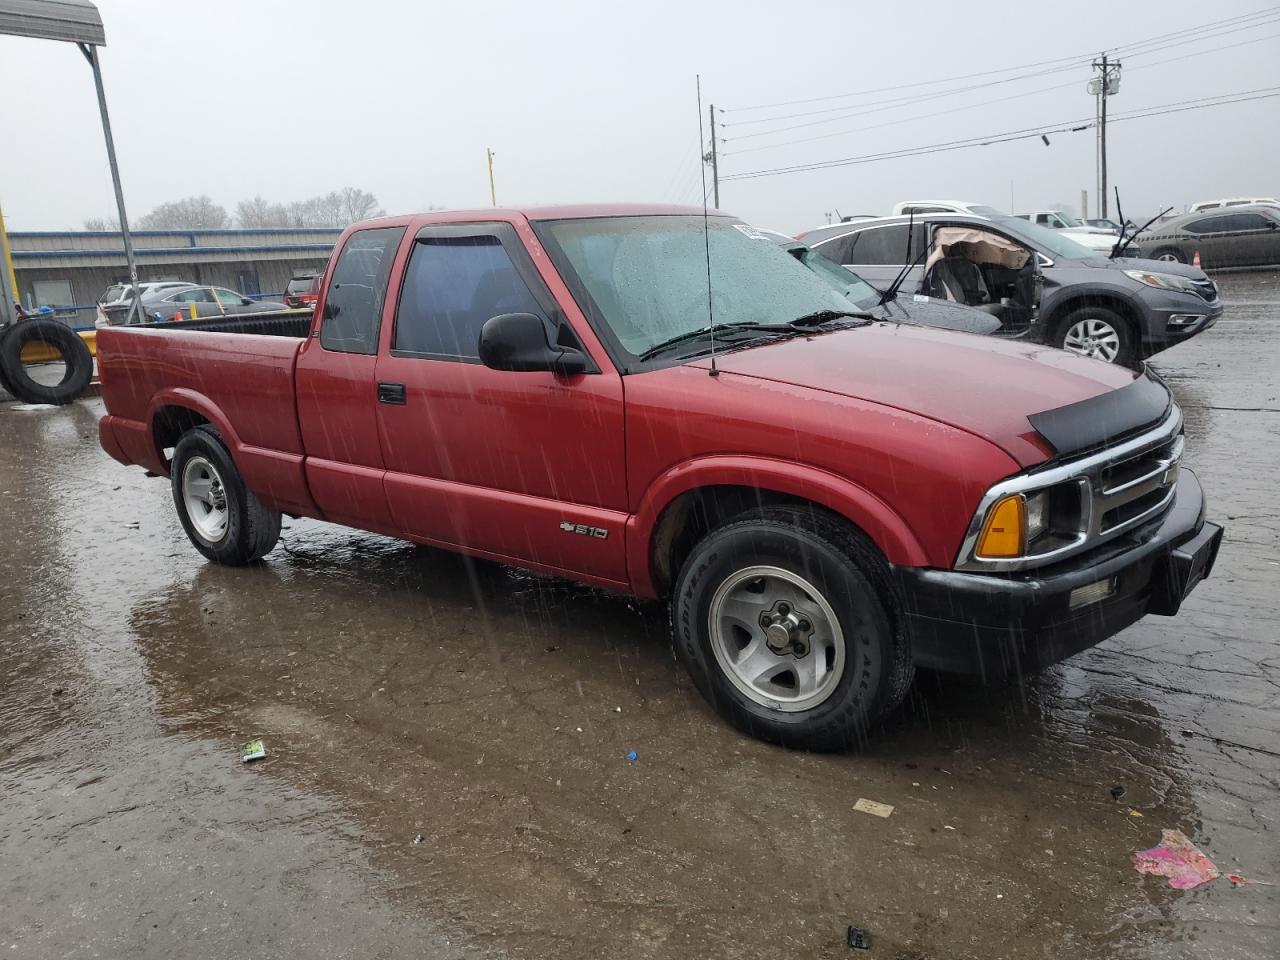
672,507,913,750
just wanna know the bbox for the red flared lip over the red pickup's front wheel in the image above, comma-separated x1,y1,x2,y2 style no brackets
627,454,928,596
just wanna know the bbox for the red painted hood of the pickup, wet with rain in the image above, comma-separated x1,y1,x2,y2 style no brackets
694,323,1146,467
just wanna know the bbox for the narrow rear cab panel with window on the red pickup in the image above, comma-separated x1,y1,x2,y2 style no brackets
297,227,404,534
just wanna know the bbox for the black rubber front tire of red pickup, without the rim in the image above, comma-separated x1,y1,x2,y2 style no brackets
671,506,914,750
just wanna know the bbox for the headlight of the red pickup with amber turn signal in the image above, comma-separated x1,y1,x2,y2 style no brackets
973,480,1088,561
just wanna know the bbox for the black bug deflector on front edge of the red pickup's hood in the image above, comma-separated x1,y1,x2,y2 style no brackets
1027,367,1172,457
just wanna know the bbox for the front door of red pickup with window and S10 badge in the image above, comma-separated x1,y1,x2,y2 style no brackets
378,221,627,584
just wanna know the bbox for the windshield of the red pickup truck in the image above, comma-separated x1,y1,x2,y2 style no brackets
535,216,850,357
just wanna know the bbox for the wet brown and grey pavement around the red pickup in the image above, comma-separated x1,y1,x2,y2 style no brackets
0,274,1280,960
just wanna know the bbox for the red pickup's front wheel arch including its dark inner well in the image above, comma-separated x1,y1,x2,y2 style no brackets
627,456,928,596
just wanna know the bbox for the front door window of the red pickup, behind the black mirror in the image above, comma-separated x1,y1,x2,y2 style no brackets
392,236,547,360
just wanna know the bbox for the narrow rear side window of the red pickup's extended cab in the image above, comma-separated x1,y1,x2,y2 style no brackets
320,227,404,355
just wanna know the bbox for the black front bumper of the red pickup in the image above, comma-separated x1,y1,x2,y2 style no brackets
893,468,1222,677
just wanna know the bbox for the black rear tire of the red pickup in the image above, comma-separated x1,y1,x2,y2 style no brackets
169,425,280,567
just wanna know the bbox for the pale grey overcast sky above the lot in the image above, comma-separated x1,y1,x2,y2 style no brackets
0,0,1280,232
